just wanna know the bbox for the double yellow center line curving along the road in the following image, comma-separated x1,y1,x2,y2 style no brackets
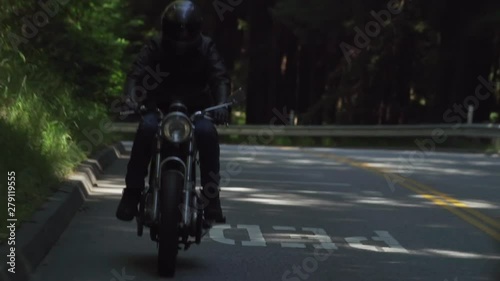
306,153,500,241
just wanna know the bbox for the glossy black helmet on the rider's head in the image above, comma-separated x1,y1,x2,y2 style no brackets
161,0,203,54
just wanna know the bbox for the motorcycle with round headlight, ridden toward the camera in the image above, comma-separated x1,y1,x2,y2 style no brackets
120,88,243,277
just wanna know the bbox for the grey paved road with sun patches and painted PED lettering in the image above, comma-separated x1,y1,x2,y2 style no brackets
28,143,500,281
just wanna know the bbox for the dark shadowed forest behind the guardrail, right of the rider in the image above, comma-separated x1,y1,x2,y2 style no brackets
197,0,500,124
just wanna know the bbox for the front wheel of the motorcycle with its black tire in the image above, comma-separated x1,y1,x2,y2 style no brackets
158,170,184,277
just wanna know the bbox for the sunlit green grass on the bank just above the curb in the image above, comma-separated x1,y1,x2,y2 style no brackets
0,85,117,243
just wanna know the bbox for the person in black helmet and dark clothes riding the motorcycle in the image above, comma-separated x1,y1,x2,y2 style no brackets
116,0,231,222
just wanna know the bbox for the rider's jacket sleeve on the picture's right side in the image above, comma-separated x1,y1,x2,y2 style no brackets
208,40,231,104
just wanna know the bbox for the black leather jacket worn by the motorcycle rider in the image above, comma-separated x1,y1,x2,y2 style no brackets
125,35,231,112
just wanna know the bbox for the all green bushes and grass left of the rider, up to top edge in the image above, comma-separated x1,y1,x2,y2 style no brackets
0,0,139,238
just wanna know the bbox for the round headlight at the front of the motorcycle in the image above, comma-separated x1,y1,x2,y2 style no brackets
163,112,191,143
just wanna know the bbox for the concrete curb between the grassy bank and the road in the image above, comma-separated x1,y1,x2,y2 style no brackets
0,142,125,281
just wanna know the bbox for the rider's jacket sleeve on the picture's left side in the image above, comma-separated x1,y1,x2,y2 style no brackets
124,40,157,104
